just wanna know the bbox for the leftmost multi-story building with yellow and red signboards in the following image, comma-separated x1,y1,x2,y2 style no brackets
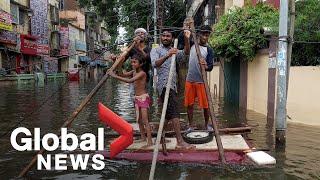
0,0,32,74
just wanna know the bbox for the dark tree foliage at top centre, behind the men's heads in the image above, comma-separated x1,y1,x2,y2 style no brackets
78,0,186,42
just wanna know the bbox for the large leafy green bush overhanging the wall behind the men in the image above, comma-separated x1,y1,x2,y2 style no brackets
209,4,279,61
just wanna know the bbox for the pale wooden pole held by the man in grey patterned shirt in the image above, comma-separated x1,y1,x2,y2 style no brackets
149,39,178,180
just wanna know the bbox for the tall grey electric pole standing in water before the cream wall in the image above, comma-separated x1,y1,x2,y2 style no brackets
276,0,289,146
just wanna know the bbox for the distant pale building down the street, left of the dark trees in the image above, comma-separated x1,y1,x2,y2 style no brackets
60,0,100,79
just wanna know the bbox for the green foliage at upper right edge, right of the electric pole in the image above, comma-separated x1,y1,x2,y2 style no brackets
291,0,320,66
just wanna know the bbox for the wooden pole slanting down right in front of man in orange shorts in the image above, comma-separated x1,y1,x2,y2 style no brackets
191,19,227,165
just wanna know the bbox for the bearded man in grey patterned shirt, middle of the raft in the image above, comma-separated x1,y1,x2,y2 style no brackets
150,29,195,149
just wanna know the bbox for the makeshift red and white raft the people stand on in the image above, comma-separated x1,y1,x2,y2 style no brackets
100,124,251,164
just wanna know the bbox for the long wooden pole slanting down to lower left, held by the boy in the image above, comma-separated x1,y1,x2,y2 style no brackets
18,43,135,178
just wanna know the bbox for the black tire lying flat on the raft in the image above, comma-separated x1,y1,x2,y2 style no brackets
182,131,213,144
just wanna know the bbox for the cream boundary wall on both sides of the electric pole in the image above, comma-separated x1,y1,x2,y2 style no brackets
247,54,320,125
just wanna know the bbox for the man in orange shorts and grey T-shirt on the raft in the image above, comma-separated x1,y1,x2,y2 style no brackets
184,26,214,131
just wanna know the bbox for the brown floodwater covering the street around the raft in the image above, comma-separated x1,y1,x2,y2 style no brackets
0,79,320,180
